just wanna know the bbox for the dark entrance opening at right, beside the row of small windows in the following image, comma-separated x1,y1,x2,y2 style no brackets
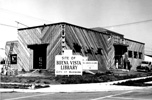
114,44,128,69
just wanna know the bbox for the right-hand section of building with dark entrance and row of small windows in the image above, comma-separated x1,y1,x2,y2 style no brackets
92,27,145,70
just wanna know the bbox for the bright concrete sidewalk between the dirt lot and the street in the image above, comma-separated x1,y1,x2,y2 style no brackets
0,76,152,92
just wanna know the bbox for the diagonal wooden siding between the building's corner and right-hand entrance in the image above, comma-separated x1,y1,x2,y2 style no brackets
65,25,114,71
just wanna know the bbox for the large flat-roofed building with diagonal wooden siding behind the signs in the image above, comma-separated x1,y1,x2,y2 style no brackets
6,22,144,71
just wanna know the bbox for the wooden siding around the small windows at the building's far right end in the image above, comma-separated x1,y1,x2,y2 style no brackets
125,39,145,70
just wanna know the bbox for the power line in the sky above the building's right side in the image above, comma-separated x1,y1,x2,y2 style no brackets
103,19,152,28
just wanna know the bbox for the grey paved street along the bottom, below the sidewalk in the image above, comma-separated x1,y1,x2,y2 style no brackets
0,87,152,100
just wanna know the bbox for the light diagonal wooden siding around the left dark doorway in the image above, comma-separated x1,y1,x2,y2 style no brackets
18,25,61,70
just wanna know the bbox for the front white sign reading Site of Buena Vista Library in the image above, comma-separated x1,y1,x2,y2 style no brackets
55,55,82,75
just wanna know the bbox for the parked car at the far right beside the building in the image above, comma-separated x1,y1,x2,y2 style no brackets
136,61,152,72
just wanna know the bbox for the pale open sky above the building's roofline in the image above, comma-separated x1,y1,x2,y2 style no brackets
0,0,152,54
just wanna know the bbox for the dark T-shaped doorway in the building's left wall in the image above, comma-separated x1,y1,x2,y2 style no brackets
28,44,48,69
